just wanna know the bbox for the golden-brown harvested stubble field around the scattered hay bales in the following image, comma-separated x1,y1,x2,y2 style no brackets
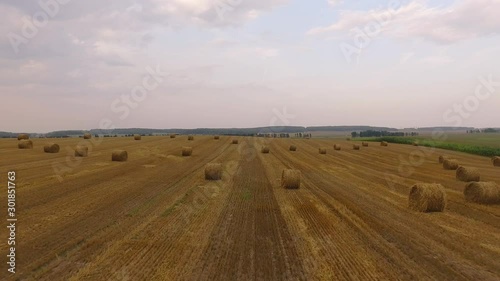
0,136,500,280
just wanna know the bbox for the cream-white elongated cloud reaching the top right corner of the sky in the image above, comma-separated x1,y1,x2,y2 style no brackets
308,0,500,44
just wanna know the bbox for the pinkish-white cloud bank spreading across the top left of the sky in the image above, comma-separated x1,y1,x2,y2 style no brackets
0,0,289,57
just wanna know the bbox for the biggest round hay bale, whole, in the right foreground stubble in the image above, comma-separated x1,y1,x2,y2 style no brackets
408,183,446,212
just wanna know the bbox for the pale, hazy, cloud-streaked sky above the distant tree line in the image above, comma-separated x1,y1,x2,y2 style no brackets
0,0,500,133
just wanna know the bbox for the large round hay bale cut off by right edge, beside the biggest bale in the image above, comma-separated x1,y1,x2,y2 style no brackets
464,182,500,204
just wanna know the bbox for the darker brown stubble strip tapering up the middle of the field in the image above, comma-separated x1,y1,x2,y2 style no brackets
193,139,305,280
